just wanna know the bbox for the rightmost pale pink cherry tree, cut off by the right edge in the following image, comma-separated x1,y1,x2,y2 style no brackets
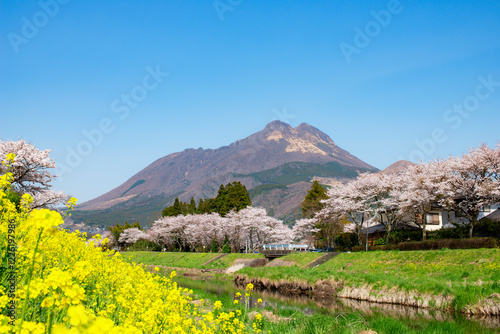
440,144,500,238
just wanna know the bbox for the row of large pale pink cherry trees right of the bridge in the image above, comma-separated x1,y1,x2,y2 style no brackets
310,143,500,243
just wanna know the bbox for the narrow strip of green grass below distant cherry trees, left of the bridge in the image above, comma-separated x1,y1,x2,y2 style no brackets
122,252,220,268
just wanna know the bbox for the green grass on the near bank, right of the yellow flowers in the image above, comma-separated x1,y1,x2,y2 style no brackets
180,282,499,334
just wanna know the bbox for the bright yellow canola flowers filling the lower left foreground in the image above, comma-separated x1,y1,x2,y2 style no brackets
0,154,262,334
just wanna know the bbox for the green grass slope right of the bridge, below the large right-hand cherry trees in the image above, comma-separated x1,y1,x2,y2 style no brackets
239,249,500,310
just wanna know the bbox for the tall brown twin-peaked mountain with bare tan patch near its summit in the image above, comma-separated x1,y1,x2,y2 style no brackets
73,121,376,225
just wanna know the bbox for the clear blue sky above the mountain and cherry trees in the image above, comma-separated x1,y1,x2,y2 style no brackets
0,0,500,202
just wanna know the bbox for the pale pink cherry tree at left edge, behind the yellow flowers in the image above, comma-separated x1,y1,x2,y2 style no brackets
0,140,69,208
